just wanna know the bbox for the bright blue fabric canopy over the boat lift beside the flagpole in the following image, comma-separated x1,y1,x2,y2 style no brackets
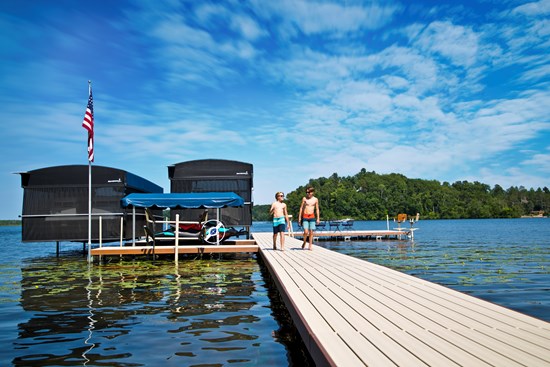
121,192,244,209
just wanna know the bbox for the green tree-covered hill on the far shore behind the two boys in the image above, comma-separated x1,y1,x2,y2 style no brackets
252,169,550,221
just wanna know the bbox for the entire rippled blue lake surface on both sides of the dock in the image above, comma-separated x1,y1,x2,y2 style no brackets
0,218,550,366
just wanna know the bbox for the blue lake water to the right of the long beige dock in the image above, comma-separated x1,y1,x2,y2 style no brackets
320,218,550,321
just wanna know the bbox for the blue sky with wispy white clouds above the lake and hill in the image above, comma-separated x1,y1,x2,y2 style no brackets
0,0,550,219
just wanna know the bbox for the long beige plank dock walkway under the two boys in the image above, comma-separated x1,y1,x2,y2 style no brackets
253,233,550,367
